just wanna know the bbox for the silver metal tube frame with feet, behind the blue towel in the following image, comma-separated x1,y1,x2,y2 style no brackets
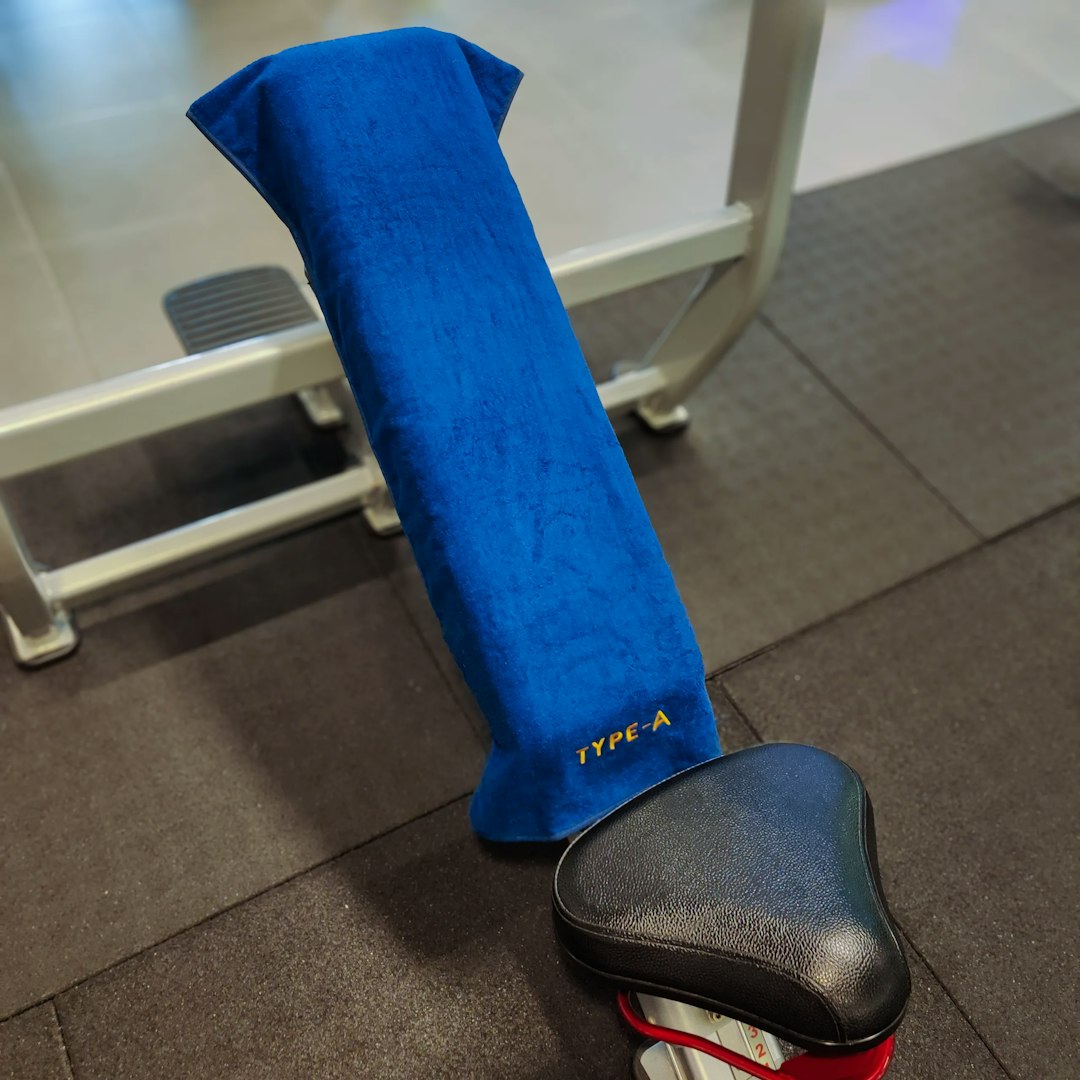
0,0,824,665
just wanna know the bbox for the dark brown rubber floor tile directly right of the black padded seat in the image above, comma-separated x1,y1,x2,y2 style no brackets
725,508,1080,1080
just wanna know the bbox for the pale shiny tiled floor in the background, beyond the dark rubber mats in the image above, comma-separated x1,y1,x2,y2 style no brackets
0,0,1080,405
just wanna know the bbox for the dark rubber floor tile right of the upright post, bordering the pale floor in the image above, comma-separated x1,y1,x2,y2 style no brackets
766,125,1080,535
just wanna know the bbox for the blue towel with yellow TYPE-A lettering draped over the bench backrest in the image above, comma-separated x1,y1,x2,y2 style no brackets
188,23,719,840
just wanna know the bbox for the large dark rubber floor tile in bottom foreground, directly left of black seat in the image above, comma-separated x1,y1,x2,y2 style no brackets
58,800,631,1080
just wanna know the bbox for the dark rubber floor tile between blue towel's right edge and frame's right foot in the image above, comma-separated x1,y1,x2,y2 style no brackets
618,326,974,671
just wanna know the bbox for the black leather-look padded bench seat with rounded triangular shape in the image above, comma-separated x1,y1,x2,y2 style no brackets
554,743,910,1051
